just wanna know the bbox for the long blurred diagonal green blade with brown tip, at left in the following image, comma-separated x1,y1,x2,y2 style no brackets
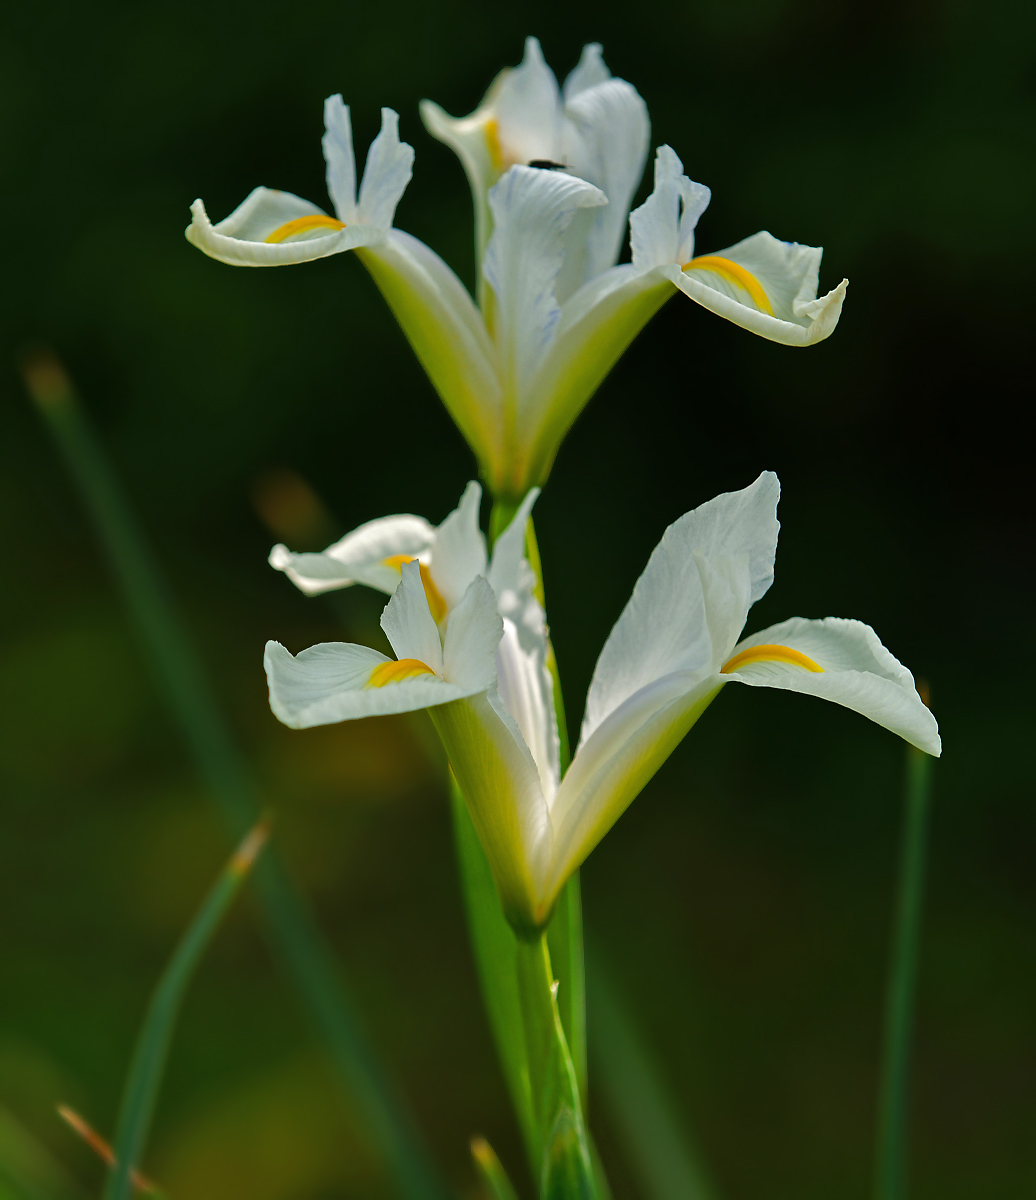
23,354,443,1200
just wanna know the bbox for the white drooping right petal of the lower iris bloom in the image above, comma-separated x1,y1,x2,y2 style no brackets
725,617,942,755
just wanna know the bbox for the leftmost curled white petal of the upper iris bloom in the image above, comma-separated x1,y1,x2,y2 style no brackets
186,187,383,266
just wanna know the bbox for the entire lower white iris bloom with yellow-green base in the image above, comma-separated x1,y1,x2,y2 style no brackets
267,472,941,932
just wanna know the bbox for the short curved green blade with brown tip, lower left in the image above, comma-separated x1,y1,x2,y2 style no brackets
103,822,269,1200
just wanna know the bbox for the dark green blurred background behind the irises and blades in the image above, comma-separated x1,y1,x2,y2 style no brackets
0,0,1036,1200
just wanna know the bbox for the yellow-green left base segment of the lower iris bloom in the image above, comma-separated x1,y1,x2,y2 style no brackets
429,692,551,929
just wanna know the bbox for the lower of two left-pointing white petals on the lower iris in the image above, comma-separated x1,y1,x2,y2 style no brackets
265,642,466,730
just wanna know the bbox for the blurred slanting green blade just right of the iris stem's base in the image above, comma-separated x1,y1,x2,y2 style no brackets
587,953,717,1200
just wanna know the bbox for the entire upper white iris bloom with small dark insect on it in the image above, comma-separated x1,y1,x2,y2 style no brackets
187,38,846,502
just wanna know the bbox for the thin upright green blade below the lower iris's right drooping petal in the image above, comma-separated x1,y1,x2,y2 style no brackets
874,744,934,1200
